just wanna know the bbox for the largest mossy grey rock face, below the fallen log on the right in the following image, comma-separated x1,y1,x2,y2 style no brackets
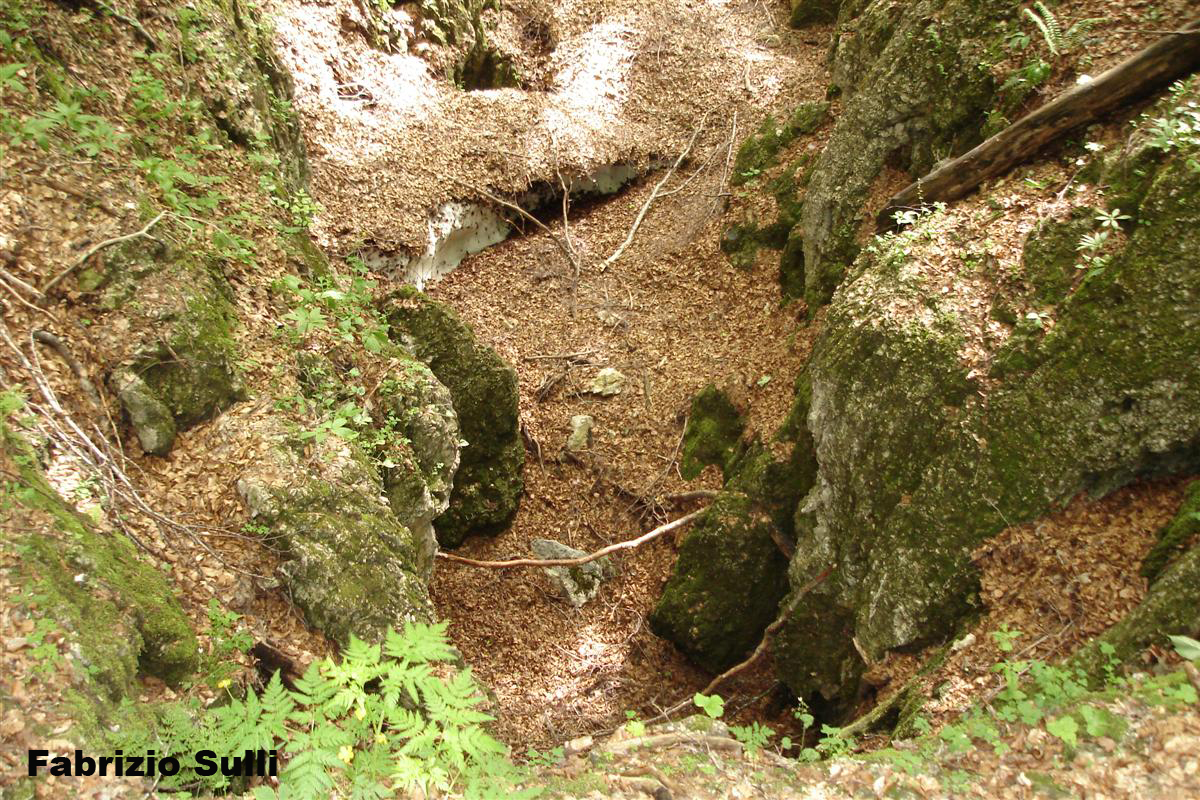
775,133,1200,702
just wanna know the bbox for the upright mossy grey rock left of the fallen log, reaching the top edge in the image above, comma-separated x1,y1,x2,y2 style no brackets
800,0,1020,308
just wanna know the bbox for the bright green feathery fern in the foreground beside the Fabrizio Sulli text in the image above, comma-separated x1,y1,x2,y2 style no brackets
113,622,538,800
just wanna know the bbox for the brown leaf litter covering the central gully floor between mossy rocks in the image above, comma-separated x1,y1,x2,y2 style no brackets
270,0,828,746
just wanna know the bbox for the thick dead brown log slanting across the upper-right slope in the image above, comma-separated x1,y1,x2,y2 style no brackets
875,19,1200,233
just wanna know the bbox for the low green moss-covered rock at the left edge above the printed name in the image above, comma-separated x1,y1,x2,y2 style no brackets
0,422,199,703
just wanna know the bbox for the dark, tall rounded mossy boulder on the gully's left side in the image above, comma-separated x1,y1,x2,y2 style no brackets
385,289,524,547
